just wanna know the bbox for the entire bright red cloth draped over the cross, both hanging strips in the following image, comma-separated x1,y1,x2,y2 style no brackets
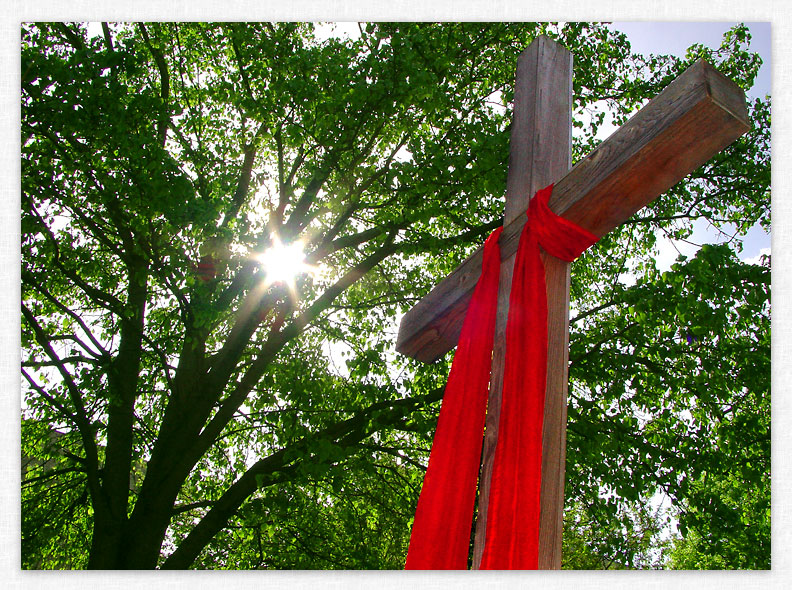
405,185,597,569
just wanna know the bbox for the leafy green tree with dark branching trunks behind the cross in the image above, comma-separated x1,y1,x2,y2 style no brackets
21,23,769,568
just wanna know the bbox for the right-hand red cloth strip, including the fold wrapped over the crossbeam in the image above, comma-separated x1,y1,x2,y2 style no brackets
481,185,597,569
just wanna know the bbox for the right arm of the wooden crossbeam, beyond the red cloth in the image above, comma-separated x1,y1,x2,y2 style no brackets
550,59,750,237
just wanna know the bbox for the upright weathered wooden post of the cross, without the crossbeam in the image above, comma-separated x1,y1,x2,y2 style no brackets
473,37,572,569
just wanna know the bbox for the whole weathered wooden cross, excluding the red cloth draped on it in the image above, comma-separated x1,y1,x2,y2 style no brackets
396,37,749,569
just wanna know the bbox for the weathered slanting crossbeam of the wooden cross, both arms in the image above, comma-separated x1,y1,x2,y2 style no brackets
396,60,749,362
